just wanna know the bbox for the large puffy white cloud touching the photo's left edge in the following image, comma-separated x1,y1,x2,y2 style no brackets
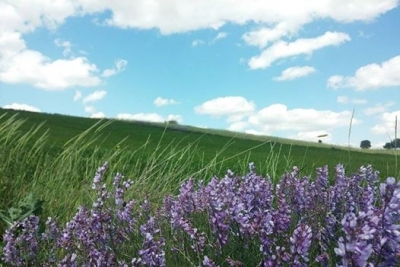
0,31,101,91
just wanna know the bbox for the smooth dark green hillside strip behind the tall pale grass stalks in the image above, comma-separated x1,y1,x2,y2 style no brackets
0,109,398,180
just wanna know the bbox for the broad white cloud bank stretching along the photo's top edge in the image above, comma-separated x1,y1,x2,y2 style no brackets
74,0,398,34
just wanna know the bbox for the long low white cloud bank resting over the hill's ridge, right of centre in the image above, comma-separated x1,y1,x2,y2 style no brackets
195,97,361,141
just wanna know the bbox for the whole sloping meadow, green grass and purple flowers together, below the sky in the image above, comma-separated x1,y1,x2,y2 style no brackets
0,109,400,266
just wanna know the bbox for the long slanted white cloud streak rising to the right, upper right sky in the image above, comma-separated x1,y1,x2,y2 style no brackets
248,32,350,69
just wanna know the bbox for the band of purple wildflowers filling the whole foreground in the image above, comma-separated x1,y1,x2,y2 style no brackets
2,163,400,266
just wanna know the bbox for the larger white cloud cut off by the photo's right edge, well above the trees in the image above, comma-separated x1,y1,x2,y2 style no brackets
327,56,400,91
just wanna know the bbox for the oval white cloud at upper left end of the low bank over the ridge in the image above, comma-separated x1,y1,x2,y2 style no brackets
194,96,255,116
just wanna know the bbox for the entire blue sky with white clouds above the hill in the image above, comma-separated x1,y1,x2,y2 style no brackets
0,0,400,148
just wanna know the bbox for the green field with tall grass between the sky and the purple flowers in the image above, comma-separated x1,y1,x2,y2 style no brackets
0,109,399,266
